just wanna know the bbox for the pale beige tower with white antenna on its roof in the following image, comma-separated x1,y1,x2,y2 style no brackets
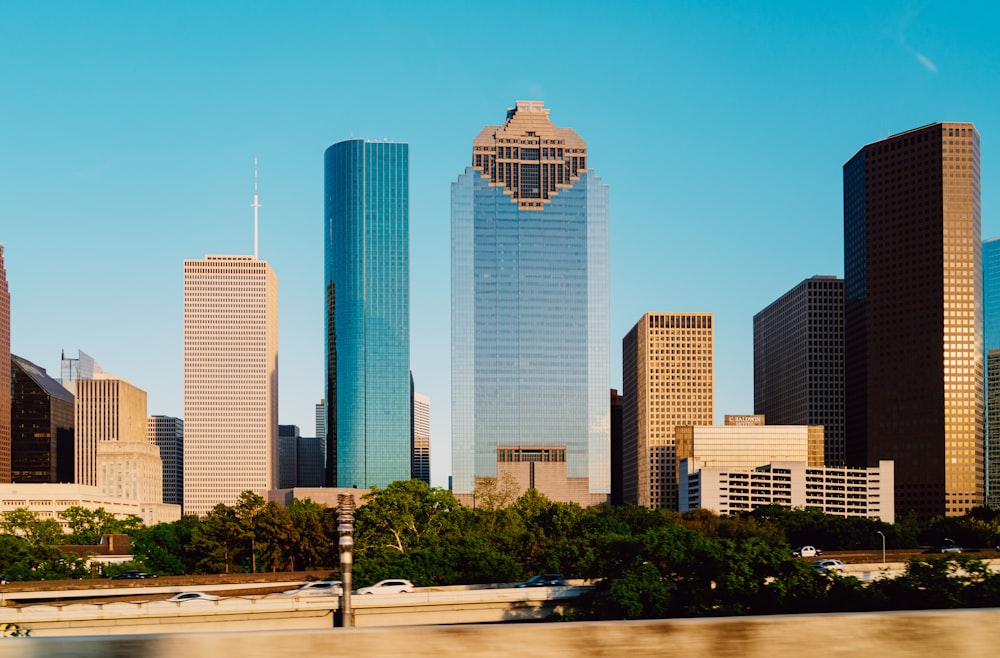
184,256,278,514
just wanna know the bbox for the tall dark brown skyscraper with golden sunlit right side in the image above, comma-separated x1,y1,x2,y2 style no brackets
844,123,984,519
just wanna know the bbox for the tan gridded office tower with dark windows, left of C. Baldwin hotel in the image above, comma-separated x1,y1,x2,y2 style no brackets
622,313,715,510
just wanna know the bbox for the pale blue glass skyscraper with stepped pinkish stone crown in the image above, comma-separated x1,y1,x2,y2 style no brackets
451,101,611,499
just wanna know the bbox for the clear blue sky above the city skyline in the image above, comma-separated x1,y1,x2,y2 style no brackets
0,0,1000,486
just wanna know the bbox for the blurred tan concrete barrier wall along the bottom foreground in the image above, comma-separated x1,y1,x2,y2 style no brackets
0,609,1000,658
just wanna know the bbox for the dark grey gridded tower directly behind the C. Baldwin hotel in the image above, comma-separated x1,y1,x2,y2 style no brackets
753,276,845,466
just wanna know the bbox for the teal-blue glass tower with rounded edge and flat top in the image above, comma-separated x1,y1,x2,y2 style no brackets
324,139,410,488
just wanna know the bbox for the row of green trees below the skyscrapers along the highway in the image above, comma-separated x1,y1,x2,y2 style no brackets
0,480,1000,619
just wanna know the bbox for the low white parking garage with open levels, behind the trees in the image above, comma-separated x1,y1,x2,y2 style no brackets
679,459,895,523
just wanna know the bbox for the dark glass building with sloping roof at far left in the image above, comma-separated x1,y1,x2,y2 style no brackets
10,355,75,484
